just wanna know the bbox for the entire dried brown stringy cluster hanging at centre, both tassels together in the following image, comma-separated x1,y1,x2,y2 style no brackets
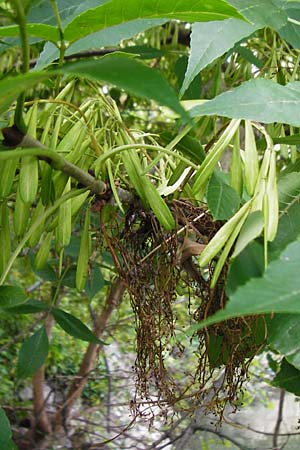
106,200,260,415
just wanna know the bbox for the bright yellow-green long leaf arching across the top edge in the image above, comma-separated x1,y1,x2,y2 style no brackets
65,0,243,42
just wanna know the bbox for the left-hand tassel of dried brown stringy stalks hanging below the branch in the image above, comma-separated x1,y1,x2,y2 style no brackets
117,207,179,397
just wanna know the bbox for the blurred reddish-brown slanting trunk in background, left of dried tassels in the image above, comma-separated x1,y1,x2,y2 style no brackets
54,278,125,428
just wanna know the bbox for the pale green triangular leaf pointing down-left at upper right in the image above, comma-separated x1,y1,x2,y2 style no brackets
180,19,258,95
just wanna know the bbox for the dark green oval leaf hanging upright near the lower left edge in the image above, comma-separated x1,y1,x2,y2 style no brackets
17,326,49,378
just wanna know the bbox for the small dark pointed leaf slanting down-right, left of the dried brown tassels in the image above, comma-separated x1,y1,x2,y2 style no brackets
52,308,107,345
